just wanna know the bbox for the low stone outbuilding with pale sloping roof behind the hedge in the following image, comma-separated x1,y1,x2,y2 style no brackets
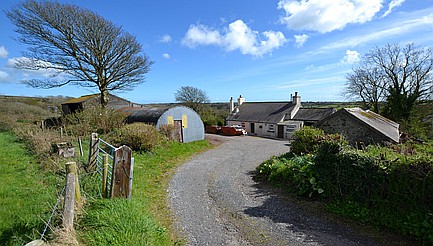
315,108,400,145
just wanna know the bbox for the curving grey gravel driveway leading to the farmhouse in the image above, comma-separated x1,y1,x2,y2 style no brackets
168,136,384,245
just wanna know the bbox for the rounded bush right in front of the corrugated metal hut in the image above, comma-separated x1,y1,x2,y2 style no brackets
109,122,164,151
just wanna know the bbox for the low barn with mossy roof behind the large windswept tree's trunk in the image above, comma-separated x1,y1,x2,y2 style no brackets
62,94,140,114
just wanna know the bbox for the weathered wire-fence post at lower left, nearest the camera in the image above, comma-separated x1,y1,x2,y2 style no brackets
63,173,75,229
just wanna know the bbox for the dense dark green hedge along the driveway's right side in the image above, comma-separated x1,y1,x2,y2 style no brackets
257,128,433,244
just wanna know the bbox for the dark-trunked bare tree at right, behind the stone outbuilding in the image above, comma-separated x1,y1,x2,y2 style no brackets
347,43,433,120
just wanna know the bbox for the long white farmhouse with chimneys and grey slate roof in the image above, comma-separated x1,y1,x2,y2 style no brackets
227,92,336,139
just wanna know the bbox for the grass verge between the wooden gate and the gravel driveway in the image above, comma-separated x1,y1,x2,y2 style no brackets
79,141,210,245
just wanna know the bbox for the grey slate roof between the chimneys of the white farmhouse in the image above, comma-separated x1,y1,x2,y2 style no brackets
227,102,295,123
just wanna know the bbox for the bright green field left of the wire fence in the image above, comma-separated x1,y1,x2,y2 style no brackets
0,132,57,245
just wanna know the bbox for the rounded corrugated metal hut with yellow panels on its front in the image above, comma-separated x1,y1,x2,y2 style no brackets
119,105,204,143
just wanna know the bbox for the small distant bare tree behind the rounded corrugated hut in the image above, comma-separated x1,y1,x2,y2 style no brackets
174,86,210,113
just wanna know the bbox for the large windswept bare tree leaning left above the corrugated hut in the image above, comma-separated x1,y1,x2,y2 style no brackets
6,0,153,107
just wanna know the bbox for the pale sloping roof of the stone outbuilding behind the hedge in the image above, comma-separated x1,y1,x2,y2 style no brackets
341,108,400,143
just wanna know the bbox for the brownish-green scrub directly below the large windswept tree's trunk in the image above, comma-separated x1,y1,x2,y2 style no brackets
65,107,126,136
